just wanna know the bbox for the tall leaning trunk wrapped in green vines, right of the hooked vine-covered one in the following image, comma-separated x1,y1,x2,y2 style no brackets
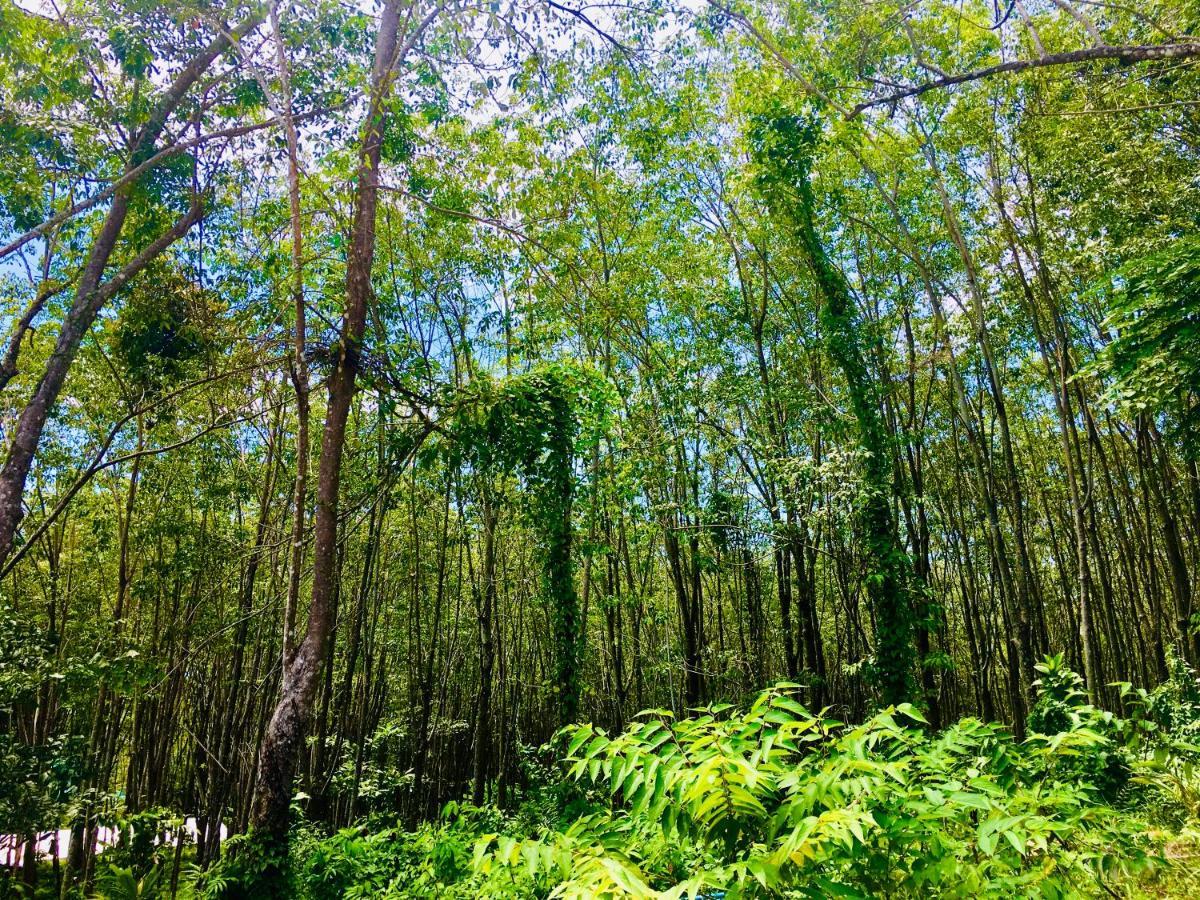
751,115,913,703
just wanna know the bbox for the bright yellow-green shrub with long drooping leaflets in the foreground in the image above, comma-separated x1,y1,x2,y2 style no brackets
496,685,1154,898
